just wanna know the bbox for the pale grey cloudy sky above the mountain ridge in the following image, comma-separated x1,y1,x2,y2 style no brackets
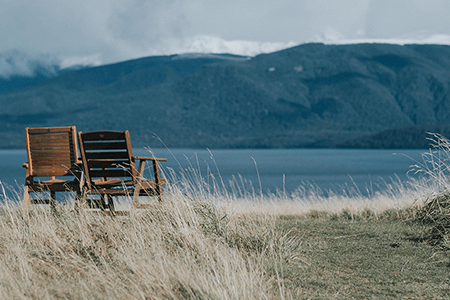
0,0,450,75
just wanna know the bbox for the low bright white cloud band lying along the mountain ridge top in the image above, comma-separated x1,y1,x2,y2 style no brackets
4,32,450,79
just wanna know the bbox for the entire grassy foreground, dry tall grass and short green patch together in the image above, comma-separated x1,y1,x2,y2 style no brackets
0,135,450,299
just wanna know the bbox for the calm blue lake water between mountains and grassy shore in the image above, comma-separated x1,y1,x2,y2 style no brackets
0,149,425,198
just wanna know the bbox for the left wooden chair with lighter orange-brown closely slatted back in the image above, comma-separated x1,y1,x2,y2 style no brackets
22,126,82,210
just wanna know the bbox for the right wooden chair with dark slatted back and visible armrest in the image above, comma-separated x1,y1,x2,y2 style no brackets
78,130,167,214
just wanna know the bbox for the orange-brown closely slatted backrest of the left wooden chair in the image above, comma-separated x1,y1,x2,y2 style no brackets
25,126,80,177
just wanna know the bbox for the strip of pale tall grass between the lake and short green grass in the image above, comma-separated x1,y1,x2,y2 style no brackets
164,149,432,217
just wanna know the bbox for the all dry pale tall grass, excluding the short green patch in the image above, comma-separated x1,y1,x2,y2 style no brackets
0,139,447,299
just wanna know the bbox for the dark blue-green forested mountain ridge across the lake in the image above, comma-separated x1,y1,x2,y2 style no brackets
0,44,450,148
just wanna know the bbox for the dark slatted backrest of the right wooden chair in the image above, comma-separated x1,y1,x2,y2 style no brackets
78,130,136,187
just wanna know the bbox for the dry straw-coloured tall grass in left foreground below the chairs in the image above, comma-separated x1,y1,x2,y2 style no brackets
0,178,301,299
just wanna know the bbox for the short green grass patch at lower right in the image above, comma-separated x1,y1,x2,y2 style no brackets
277,213,450,299
